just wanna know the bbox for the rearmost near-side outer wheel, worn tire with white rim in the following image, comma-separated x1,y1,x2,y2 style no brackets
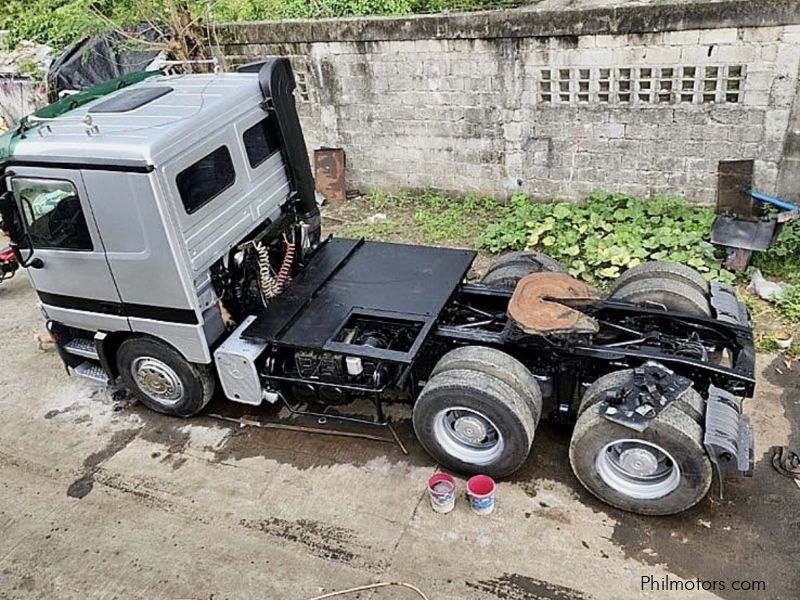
569,404,712,515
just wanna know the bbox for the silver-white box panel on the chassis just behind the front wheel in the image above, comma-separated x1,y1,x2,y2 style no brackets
214,316,267,406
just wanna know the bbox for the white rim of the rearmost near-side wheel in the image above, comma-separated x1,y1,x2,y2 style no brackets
595,439,681,500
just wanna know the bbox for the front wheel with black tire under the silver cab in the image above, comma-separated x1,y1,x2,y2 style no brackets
117,336,214,417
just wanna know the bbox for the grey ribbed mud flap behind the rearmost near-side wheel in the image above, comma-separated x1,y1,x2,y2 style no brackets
703,385,753,498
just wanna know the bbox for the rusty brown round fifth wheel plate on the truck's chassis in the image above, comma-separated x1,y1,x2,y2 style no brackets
508,273,597,334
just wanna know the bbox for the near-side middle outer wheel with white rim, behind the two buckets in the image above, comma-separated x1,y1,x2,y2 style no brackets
413,369,536,477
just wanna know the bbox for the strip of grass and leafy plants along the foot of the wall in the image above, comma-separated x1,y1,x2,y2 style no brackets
340,191,800,350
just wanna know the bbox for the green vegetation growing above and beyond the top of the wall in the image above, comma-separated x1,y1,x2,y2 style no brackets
0,0,524,48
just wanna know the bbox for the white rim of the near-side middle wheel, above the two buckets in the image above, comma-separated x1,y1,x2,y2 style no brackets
433,406,505,465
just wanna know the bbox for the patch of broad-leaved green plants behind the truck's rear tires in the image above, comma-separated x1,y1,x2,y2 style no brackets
478,192,734,286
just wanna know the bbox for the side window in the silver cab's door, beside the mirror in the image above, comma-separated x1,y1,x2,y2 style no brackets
12,177,92,250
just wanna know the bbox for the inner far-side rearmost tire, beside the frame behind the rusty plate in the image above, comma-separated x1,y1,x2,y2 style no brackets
609,277,711,317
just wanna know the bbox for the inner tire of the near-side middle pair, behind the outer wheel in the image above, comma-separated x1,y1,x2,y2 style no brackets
430,346,542,425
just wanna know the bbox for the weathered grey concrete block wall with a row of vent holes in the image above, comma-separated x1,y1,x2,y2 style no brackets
218,0,800,203
